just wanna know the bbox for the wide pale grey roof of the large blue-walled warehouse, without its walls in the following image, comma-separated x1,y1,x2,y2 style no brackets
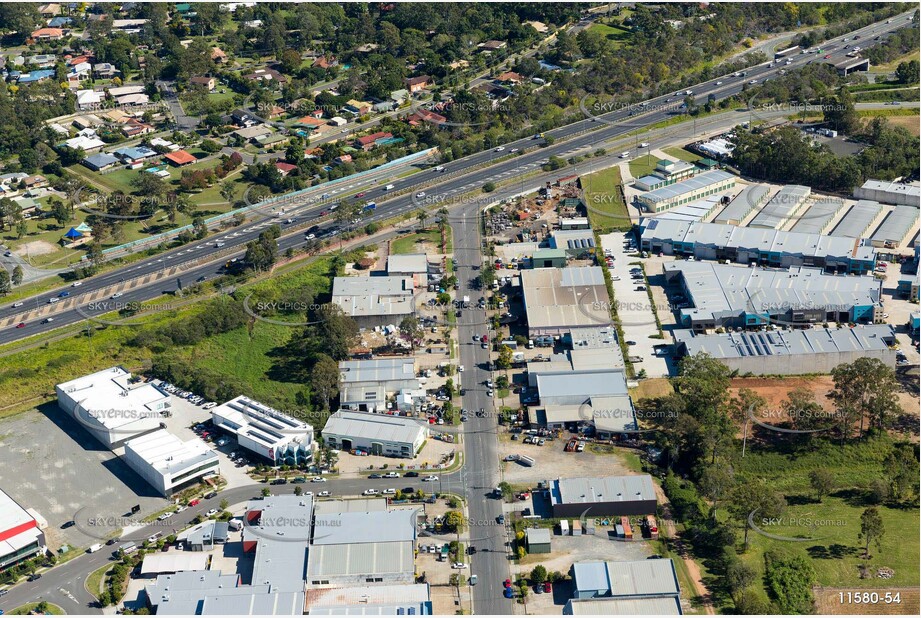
664,261,880,320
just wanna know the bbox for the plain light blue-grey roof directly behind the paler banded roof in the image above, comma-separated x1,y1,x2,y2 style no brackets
313,509,417,546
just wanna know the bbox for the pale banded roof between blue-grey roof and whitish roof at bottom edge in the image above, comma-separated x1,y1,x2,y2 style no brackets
307,541,415,580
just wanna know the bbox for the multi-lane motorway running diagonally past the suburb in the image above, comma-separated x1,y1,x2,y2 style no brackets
0,13,911,343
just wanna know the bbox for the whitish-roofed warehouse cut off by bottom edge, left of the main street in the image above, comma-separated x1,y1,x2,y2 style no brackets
307,584,432,616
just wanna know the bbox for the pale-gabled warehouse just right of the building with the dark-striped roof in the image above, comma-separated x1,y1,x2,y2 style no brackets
323,410,428,459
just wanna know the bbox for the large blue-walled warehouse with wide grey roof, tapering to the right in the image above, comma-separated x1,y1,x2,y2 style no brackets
663,261,882,331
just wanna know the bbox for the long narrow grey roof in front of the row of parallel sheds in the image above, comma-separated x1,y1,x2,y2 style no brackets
642,219,876,261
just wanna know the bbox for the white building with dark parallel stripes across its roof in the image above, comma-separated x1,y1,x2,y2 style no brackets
211,395,313,466
